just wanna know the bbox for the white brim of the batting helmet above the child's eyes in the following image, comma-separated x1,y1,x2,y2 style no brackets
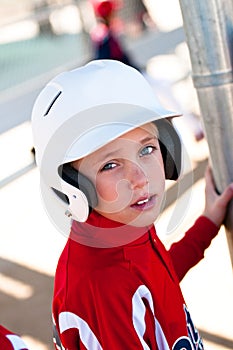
62,104,180,164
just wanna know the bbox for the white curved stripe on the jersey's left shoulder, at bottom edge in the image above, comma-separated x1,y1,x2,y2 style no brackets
59,312,103,350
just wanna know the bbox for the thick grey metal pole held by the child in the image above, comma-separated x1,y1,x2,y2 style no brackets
180,0,233,265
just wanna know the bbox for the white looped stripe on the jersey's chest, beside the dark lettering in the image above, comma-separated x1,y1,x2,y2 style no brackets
132,285,169,350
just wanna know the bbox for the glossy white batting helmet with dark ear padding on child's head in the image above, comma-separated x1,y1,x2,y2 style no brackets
32,60,181,221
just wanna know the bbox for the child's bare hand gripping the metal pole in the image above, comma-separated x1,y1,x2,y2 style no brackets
203,165,233,226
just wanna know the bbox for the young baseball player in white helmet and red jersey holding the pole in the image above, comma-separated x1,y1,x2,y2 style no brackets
32,60,233,350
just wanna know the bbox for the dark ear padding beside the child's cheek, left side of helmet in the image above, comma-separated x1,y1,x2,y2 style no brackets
61,163,98,213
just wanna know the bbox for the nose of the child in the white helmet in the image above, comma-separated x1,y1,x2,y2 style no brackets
127,162,148,189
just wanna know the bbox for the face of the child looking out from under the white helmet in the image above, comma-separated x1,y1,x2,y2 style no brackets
72,123,165,227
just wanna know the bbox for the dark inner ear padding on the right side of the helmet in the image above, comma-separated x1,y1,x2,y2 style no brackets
155,120,182,180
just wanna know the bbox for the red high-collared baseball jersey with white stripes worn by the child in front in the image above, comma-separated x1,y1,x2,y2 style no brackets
53,212,218,350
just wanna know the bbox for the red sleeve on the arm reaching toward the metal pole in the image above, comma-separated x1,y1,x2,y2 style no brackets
169,216,219,281
